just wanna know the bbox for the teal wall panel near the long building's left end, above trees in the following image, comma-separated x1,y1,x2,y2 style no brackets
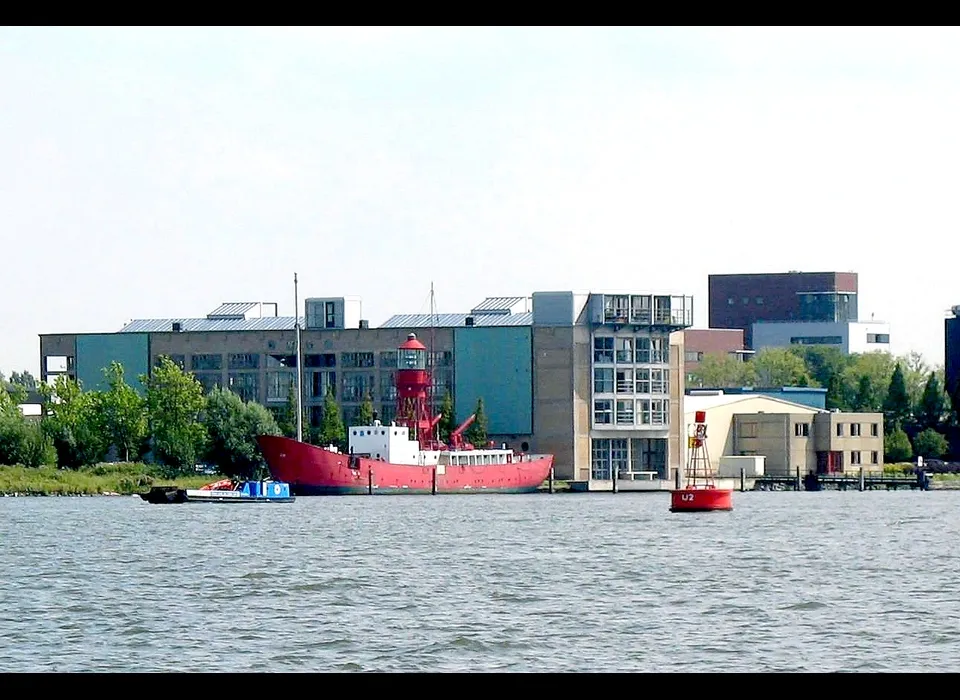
76,333,150,393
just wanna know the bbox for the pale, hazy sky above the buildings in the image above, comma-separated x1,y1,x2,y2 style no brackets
0,27,960,376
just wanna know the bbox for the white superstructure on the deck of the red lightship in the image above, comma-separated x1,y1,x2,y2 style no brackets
347,421,520,466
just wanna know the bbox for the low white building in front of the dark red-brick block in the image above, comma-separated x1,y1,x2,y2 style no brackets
752,321,890,355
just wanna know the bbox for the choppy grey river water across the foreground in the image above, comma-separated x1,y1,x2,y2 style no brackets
0,491,960,672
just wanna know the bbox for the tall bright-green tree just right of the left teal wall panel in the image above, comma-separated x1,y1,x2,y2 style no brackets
140,356,206,473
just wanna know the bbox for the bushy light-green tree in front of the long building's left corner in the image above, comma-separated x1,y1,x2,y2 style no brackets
39,375,110,469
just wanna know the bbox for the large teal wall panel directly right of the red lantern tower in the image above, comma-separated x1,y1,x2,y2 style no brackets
453,326,533,435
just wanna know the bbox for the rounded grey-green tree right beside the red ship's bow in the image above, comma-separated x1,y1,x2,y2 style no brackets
203,386,280,479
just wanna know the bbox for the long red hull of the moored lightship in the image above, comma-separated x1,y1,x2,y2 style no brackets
257,435,553,496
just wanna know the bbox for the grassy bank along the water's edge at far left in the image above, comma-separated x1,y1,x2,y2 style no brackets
0,462,222,496
